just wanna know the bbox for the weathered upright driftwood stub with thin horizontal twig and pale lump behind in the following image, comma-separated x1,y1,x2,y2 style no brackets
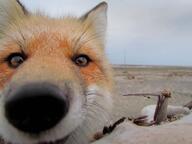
123,90,192,126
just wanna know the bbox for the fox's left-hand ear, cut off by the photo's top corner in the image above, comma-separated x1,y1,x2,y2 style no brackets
0,0,28,37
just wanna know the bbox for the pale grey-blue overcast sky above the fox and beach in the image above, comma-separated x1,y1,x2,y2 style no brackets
21,0,192,66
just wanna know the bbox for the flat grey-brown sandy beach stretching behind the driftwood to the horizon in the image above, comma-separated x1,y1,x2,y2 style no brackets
114,66,192,117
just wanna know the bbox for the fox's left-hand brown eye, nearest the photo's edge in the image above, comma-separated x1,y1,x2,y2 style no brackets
7,53,25,68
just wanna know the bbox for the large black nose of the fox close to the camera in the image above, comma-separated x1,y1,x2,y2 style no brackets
5,83,69,134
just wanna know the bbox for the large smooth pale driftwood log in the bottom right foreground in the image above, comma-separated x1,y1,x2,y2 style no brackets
92,114,192,144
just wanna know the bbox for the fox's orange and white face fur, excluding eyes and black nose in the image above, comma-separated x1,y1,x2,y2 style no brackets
0,0,113,144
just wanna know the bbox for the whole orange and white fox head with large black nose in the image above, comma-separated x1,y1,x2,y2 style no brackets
0,0,113,144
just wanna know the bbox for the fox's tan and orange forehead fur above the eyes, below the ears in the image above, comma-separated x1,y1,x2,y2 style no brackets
1,17,104,59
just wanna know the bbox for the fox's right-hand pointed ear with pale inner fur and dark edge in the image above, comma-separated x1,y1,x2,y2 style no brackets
80,2,108,41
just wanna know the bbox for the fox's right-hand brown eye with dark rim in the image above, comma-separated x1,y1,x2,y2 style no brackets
73,55,91,67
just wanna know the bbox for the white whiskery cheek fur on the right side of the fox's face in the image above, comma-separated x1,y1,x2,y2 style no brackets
66,85,112,144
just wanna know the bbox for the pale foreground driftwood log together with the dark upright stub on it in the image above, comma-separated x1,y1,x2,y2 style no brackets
92,91,192,144
